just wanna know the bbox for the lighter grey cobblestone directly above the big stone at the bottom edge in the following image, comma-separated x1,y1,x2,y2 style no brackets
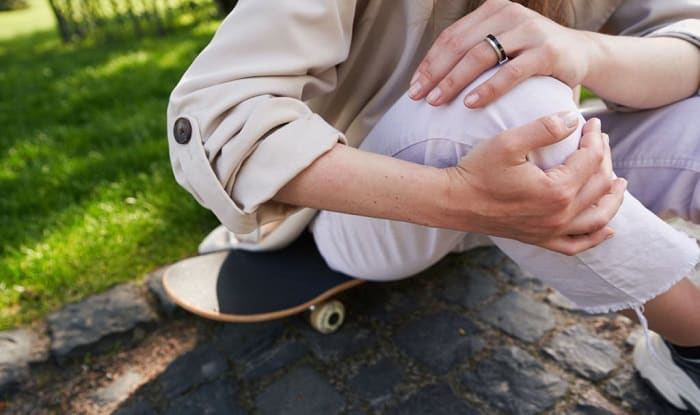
479,291,555,342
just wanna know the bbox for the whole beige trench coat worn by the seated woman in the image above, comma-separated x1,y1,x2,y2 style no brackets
168,0,700,245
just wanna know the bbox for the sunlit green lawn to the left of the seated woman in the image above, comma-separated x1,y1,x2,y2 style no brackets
0,1,217,329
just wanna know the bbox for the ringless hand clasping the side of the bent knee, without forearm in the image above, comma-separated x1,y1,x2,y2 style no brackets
444,114,627,255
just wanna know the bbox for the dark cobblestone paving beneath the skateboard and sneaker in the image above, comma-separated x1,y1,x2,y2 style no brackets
8,219,700,415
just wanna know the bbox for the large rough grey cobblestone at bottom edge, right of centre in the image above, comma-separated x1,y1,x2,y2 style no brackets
461,346,569,415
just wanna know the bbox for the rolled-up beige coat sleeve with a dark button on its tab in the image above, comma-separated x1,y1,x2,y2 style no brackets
167,0,356,233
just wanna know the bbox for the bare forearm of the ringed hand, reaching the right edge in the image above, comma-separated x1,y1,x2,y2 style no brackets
583,33,700,108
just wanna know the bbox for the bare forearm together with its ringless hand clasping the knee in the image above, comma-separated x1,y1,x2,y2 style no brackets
274,113,625,255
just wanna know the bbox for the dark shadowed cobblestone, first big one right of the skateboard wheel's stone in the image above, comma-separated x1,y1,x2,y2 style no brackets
394,312,484,374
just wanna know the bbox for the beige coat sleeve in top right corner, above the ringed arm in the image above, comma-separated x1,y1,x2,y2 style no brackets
606,0,700,111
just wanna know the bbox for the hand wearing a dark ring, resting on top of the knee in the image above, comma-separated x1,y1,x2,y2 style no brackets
409,0,592,108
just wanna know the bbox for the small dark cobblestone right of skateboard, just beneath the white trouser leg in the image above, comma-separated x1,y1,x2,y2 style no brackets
438,269,498,309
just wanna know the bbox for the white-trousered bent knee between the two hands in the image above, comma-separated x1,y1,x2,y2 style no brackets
360,68,583,167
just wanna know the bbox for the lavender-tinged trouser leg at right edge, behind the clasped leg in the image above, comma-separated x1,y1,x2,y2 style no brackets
586,96,700,223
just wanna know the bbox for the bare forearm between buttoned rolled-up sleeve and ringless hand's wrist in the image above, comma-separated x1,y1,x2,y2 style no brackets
274,144,452,230
